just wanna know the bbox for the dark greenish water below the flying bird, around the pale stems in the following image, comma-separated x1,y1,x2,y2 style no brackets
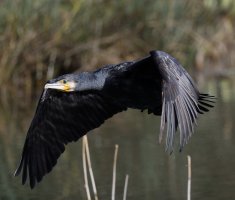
0,88,235,200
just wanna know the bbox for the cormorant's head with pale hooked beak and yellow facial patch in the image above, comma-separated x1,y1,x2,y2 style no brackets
44,74,77,92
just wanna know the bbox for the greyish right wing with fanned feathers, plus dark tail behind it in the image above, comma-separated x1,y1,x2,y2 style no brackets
150,51,214,151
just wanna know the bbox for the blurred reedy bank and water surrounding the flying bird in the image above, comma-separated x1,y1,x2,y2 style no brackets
0,0,235,200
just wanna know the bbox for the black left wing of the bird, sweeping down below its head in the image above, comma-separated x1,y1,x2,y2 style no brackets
15,89,126,188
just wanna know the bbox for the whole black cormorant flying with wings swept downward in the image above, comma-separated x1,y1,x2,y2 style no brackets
15,51,214,188
